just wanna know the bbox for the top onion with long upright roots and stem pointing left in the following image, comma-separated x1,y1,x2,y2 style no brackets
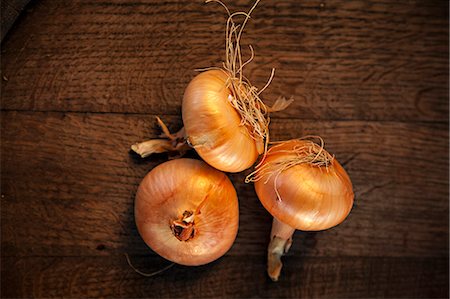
132,0,293,172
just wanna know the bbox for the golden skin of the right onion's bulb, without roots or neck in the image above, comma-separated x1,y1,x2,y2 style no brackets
255,140,354,231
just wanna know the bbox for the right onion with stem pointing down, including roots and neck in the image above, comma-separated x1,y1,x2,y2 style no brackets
246,139,354,281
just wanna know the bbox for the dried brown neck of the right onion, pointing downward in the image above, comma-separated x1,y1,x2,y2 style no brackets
267,217,295,281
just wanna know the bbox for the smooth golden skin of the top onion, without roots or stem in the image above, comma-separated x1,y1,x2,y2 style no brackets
182,70,259,172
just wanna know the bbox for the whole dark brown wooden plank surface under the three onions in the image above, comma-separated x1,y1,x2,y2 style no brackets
1,0,449,298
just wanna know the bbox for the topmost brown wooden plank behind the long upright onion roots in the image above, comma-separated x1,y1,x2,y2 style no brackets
1,0,449,121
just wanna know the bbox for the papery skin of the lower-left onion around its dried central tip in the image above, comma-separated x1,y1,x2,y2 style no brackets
135,159,239,266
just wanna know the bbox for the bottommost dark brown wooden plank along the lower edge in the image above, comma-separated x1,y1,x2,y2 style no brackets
1,256,448,298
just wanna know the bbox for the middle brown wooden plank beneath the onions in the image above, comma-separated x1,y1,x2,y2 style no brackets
1,112,448,257
